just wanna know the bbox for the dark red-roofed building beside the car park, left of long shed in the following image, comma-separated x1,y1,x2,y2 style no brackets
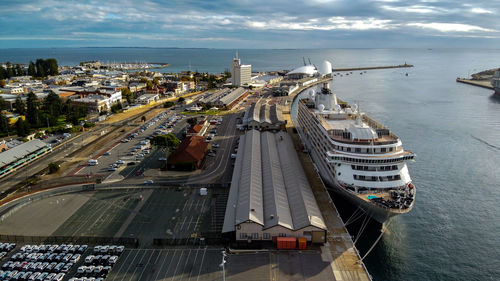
167,136,208,171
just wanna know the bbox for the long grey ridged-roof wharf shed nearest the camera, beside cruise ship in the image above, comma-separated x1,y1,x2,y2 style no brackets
222,130,327,243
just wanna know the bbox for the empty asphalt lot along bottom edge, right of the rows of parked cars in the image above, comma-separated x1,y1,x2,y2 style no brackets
106,247,336,281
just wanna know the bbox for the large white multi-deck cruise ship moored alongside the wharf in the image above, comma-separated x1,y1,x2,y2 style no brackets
296,83,416,224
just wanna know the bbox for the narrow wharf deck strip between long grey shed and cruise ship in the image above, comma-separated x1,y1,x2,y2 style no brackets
283,108,372,281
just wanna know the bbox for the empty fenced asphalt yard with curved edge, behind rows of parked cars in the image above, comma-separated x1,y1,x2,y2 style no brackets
0,188,212,246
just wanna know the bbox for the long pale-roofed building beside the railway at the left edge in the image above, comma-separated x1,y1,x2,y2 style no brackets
0,139,52,178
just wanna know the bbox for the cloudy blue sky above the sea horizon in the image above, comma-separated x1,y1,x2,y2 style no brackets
0,0,500,48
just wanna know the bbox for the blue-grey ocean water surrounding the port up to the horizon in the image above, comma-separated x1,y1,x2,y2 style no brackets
0,48,500,281
